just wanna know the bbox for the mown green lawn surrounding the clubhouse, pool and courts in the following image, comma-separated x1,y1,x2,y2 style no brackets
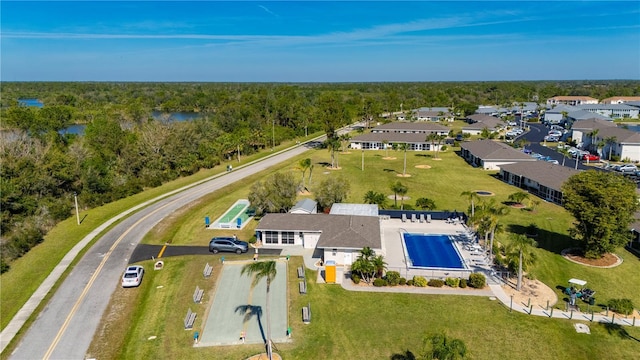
2,136,640,359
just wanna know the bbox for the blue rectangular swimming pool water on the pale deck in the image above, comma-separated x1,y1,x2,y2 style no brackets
403,234,465,269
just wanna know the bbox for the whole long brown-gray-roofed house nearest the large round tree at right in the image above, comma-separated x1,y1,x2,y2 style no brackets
499,161,579,205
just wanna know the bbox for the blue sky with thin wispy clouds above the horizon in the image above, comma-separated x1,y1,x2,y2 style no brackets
0,0,640,82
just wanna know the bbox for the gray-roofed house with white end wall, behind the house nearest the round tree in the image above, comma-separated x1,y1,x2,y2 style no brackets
460,140,538,170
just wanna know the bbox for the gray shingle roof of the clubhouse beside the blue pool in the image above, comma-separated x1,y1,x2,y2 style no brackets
256,214,382,249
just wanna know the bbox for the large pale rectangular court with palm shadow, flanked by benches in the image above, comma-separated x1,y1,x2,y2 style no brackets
198,260,289,346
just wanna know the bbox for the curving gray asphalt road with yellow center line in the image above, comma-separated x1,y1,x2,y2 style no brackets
8,139,322,360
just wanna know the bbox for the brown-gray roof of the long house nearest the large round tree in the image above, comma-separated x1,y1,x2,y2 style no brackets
499,161,579,191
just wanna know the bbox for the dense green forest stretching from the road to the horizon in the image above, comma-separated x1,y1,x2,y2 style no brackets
0,80,640,272
